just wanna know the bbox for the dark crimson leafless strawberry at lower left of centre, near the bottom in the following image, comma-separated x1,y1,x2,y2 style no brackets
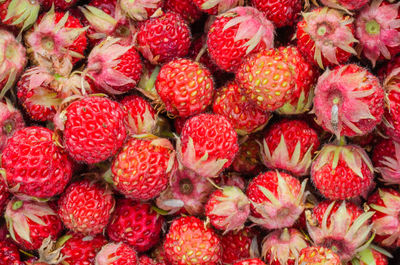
107,199,164,252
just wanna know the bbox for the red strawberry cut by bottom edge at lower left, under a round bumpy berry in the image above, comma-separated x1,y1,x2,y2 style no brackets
58,232,108,265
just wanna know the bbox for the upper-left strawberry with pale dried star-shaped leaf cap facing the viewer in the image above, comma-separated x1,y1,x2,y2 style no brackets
25,8,87,71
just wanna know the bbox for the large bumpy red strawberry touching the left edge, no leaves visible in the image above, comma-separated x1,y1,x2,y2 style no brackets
2,127,72,198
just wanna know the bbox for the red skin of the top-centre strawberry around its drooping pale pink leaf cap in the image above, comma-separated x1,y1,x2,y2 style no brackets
207,16,267,72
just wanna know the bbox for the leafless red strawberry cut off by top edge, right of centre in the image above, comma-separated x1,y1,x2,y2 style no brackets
251,0,302,28
